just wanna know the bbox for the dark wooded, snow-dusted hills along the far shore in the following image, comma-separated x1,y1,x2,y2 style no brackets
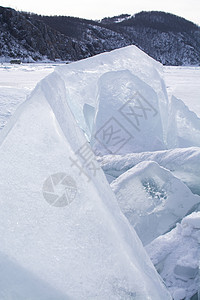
0,7,200,66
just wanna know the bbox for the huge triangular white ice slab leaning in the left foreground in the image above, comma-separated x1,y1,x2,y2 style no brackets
0,69,171,300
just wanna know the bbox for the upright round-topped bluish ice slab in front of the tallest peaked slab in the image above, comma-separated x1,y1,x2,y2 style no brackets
91,70,165,155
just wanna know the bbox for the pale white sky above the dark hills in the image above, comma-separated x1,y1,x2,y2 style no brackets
0,0,200,25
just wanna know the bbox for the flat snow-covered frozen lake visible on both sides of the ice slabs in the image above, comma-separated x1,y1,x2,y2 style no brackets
0,63,200,129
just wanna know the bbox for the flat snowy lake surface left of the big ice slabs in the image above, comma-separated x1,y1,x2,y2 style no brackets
0,63,56,130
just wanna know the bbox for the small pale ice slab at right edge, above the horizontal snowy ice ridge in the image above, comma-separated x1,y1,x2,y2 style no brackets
167,96,200,148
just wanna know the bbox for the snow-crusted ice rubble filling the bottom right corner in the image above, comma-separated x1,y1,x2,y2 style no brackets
146,212,200,300
